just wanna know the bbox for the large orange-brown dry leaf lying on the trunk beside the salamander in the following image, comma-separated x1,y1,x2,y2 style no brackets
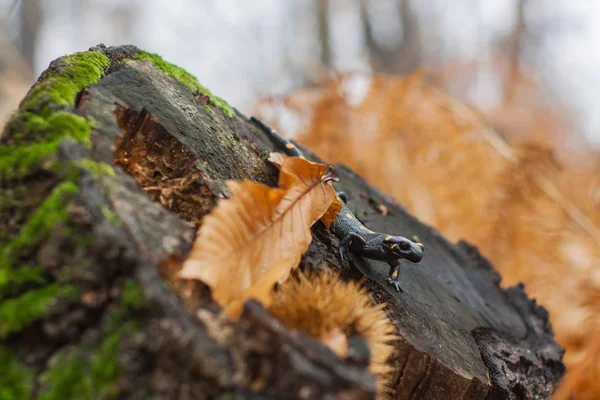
179,157,335,317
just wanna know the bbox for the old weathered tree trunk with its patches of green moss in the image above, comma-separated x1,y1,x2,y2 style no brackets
0,45,564,399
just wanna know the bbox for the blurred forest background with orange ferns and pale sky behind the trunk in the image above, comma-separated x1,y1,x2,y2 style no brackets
0,0,600,399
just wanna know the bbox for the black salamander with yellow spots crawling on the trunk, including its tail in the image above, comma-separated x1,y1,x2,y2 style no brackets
251,117,424,292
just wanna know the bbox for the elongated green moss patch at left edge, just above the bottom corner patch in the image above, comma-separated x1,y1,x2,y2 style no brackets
0,284,78,338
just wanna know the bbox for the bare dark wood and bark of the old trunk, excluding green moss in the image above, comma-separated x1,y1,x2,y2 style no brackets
0,47,564,399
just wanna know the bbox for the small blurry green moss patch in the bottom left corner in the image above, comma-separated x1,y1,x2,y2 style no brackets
0,346,34,400
